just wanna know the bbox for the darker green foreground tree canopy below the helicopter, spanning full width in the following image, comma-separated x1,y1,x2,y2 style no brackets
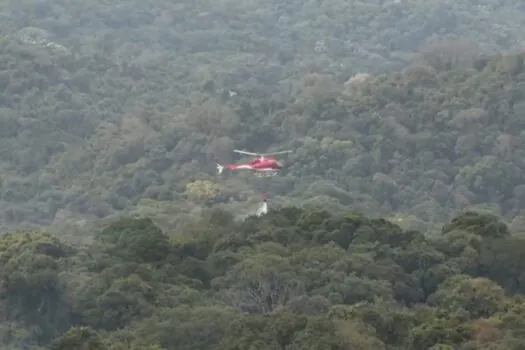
0,207,525,350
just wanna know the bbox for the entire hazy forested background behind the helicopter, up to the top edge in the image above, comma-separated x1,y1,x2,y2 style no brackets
0,0,525,234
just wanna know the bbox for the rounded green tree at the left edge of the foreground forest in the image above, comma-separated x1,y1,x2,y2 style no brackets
0,232,69,341
